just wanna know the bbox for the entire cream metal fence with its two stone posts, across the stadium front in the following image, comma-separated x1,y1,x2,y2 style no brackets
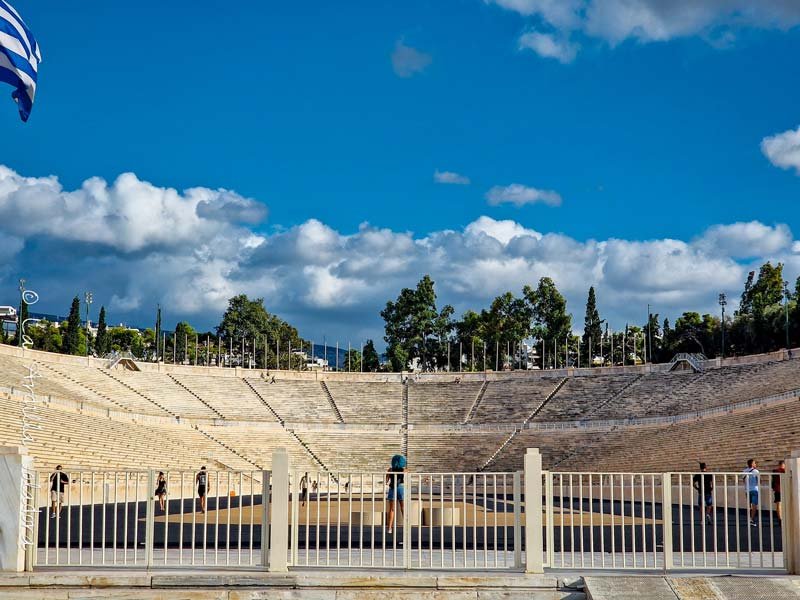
27,449,800,572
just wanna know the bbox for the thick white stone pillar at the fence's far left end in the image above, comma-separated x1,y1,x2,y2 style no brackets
0,446,33,572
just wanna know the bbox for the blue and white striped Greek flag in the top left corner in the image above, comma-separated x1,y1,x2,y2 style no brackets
0,0,42,121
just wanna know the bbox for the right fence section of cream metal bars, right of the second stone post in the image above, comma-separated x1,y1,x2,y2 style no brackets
543,472,787,570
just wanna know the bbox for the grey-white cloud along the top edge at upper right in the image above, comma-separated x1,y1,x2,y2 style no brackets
484,0,800,62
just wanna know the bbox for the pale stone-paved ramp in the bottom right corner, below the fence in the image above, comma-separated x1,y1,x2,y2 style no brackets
584,575,800,600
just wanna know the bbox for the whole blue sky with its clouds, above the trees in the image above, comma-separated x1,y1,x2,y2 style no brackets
0,0,800,339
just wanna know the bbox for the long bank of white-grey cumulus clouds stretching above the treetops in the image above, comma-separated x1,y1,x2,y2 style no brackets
0,167,800,341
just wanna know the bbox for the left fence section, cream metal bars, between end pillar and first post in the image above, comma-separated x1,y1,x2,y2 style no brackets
35,470,269,568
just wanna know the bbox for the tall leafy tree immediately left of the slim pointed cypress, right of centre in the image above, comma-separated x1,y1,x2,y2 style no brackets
523,277,572,367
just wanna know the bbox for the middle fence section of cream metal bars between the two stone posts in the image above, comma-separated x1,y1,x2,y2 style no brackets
289,472,522,570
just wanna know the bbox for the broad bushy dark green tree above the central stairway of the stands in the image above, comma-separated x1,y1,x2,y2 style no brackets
381,275,454,371
